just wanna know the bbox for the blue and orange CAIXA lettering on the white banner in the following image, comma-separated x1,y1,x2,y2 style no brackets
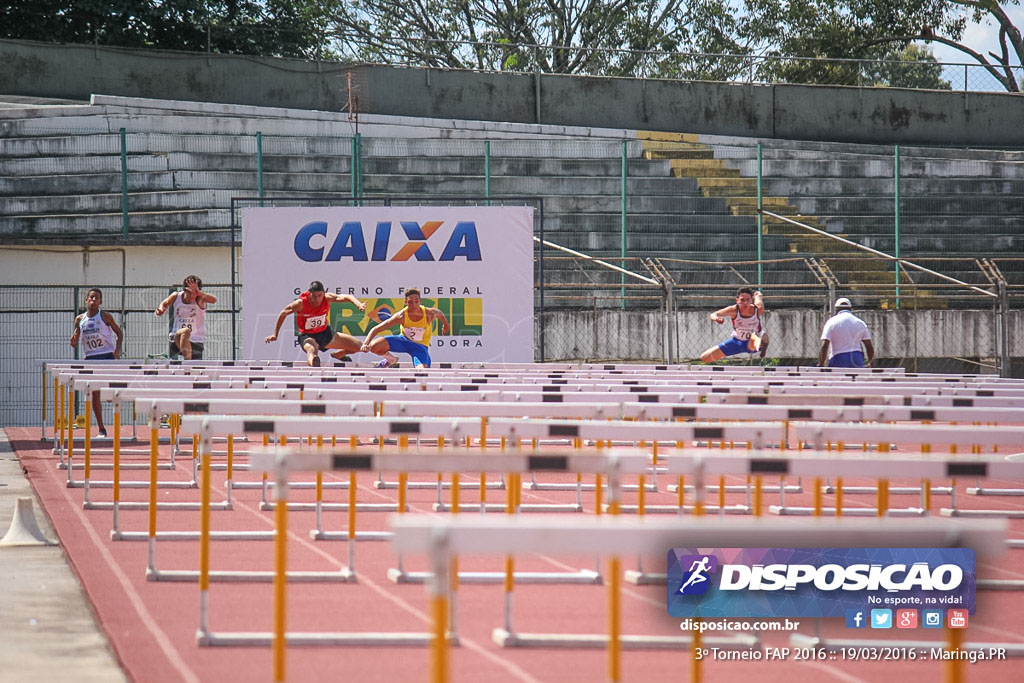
295,220,481,262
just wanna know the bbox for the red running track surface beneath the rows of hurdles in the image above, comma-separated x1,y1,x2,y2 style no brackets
7,428,1024,683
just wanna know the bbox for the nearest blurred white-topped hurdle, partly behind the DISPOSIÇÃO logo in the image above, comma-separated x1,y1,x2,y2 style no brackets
390,515,1005,681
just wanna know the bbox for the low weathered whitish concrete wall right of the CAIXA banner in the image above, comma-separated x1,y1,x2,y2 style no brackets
537,310,1024,362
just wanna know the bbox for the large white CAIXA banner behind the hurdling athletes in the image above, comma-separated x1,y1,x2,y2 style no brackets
242,207,534,364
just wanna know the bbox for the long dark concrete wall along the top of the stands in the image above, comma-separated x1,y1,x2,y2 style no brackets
0,40,1024,147
